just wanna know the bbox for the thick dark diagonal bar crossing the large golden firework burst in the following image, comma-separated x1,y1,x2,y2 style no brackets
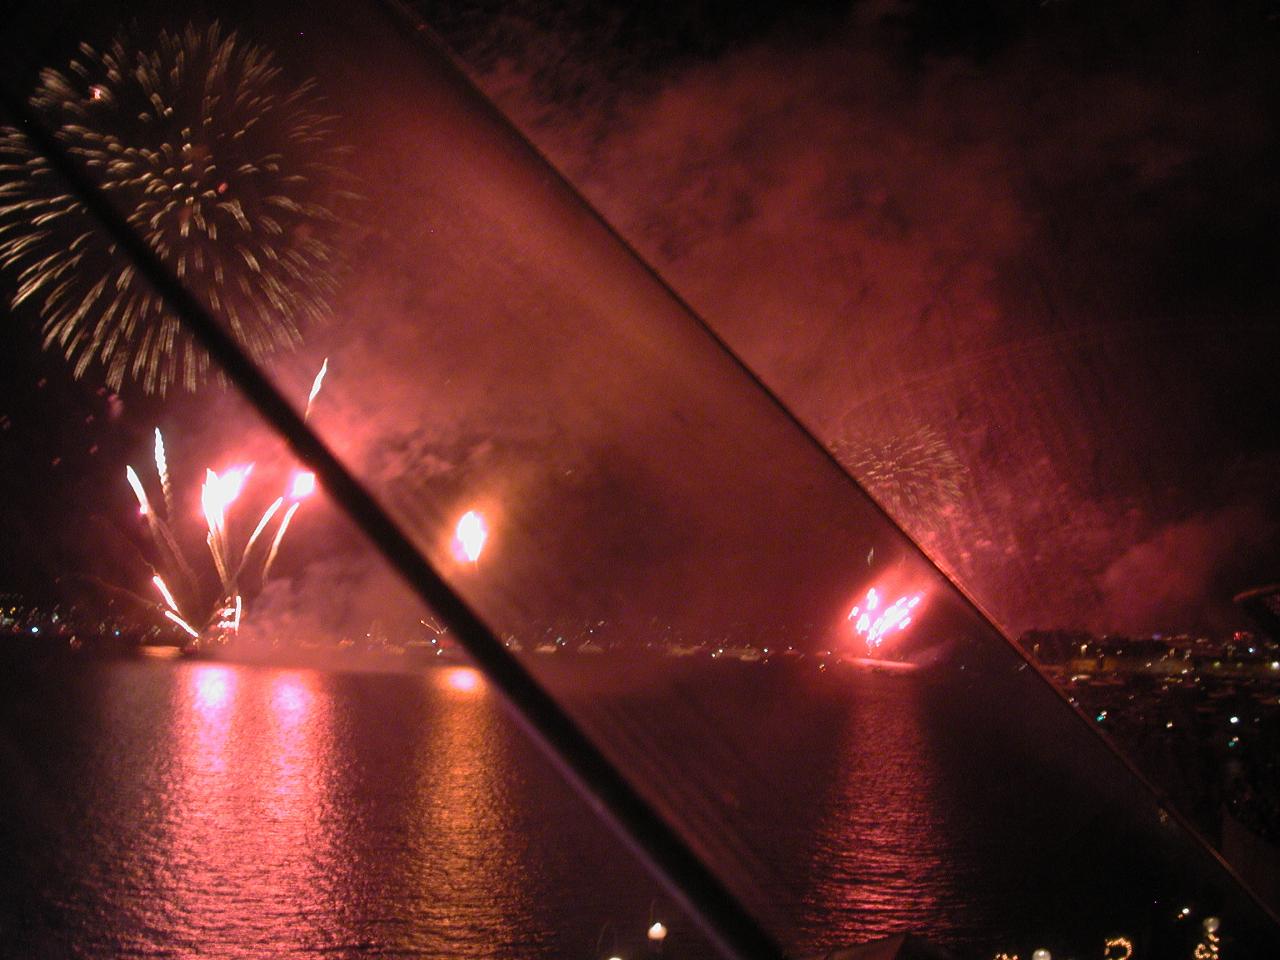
0,65,785,960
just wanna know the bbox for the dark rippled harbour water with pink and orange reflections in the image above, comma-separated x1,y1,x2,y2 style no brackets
0,657,1259,960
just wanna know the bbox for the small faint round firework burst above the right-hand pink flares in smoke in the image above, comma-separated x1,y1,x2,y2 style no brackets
831,426,968,525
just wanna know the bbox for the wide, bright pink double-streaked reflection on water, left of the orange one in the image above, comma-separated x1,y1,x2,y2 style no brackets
161,664,343,957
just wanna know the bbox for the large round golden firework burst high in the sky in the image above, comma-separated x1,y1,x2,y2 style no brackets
0,22,352,393
